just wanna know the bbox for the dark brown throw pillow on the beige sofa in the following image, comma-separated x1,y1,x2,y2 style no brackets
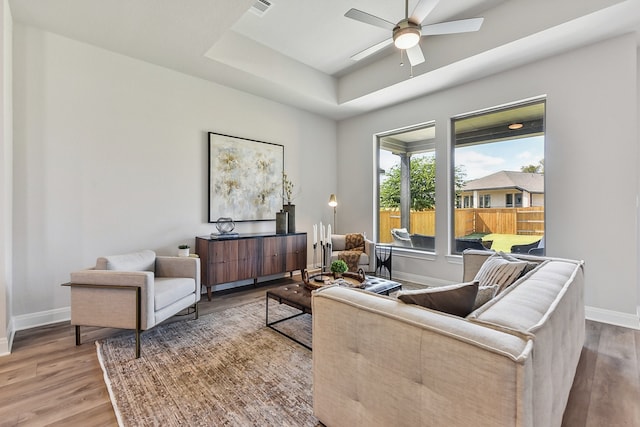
398,282,478,317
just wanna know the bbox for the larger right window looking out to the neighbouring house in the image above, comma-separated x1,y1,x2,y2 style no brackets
451,100,545,254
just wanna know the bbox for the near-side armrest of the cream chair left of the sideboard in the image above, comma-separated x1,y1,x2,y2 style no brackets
69,270,155,329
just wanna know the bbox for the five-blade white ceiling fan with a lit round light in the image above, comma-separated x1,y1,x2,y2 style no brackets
344,0,484,67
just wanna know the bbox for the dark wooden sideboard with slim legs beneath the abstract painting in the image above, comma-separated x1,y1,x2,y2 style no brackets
196,233,307,301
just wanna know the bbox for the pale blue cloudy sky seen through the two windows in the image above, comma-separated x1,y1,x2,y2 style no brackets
380,136,544,181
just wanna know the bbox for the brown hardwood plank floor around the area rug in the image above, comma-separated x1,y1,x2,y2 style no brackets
0,279,640,427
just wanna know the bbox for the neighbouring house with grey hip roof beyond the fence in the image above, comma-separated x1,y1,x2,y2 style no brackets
456,171,544,208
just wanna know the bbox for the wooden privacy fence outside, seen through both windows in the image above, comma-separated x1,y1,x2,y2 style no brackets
379,207,544,243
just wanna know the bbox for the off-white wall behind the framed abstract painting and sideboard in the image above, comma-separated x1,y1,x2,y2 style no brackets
12,23,336,329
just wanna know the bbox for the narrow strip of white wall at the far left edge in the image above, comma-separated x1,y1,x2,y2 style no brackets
0,0,13,355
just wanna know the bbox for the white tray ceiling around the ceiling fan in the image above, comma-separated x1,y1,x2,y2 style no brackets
10,0,640,119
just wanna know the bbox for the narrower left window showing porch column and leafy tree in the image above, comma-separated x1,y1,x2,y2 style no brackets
377,122,436,251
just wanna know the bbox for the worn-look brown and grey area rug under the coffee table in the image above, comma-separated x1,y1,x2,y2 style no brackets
96,301,318,426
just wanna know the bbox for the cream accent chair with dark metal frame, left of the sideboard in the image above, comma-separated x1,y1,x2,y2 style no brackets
67,250,200,358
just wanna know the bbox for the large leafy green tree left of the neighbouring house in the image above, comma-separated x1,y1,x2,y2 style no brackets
380,156,465,211
